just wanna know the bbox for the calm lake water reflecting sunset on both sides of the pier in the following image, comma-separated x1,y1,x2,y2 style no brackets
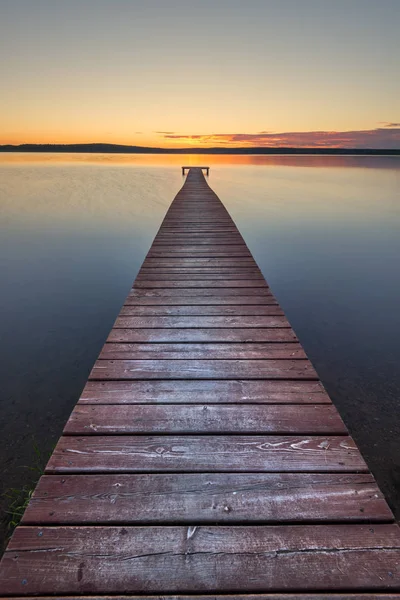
0,154,400,544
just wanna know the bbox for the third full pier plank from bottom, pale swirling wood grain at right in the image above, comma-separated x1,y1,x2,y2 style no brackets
46,435,368,474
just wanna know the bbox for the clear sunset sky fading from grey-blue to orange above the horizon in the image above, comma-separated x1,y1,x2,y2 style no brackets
0,0,400,148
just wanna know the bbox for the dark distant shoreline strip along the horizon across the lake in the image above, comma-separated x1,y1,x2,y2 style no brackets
0,143,400,156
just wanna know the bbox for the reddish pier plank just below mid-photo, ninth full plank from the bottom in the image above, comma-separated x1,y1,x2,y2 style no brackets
114,315,290,329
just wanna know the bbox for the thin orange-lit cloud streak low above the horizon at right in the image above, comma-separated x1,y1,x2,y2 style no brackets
158,123,400,149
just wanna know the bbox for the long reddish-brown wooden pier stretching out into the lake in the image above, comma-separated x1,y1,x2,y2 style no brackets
0,168,400,600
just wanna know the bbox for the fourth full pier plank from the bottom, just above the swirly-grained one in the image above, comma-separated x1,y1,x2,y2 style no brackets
64,404,347,435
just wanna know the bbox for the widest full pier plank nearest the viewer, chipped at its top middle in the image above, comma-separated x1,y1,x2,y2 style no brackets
1,524,400,594
